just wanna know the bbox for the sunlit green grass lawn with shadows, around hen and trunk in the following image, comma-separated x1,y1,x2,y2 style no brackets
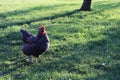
0,0,120,80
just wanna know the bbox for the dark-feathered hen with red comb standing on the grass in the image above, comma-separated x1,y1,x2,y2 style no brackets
20,26,50,63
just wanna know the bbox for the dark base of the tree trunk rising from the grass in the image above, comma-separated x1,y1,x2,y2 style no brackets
80,0,92,11
